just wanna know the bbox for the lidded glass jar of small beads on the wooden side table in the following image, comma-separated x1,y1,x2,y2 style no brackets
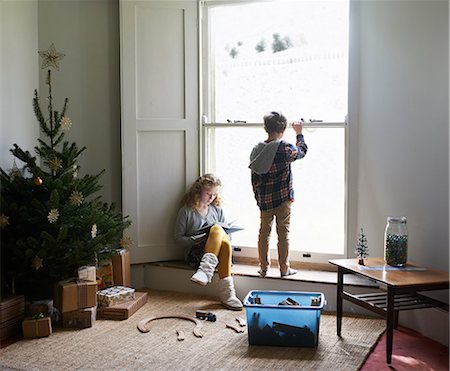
384,216,408,267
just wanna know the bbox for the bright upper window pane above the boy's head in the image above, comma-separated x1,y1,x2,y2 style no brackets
209,1,348,122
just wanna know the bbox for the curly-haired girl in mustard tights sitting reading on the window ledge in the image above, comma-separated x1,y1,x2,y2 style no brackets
175,174,242,310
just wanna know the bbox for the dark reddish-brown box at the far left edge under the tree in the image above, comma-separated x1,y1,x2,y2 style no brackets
0,295,25,341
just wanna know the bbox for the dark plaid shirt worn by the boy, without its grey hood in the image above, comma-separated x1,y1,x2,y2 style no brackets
252,134,308,211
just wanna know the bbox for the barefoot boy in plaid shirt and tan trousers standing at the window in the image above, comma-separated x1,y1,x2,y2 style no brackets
249,112,308,277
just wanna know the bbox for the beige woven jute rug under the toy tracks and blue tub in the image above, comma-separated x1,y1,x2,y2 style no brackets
0,290,385,371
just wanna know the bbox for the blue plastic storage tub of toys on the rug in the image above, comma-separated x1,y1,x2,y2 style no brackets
244,290,325,348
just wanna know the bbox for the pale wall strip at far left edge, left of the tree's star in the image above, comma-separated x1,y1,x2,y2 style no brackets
0,0,39,171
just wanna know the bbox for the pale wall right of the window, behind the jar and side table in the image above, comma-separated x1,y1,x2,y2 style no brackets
349,1,449,271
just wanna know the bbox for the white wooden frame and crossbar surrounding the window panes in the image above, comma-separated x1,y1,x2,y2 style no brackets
198,0,359,263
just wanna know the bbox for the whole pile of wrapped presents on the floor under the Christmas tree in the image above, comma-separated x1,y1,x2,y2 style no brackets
0,250,147,341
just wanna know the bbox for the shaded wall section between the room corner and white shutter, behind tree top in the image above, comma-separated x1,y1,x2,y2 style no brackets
38,0,121,207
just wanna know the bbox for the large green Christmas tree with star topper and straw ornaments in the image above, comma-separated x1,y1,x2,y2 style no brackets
0,44,131,297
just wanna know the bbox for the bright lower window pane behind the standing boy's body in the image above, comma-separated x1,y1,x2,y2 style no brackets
209,128,345,254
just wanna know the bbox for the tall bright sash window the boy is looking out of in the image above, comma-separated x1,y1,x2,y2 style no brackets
201,1,349,262
